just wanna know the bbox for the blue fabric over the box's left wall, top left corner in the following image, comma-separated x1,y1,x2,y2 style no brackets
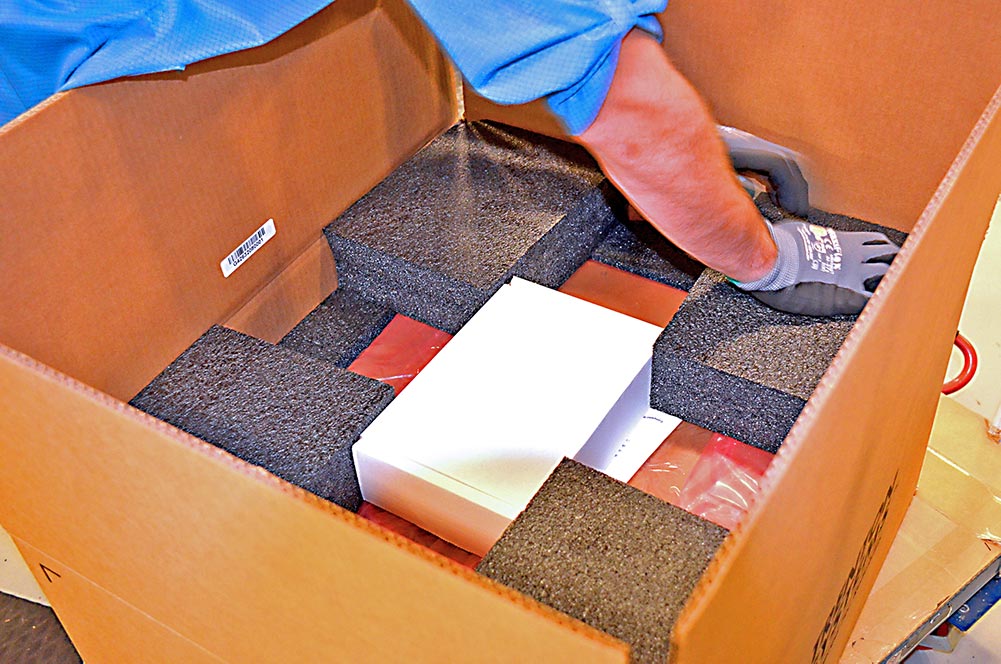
0,0,332,125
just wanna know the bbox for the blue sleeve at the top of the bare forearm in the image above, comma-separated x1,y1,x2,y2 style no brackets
409,0,667,135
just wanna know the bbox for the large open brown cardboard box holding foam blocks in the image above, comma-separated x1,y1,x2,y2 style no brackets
0,0,1001,662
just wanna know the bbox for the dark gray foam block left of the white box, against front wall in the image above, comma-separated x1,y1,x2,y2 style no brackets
131,326,393,510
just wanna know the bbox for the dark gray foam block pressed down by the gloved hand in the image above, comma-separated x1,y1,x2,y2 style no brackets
651,196,907,452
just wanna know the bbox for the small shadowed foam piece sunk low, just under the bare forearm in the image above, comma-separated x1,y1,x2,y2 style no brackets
591,219,706,290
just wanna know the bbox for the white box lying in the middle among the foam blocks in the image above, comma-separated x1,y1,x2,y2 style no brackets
353,277,679,555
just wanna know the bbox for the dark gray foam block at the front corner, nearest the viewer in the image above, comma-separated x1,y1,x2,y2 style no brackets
476,460,727,662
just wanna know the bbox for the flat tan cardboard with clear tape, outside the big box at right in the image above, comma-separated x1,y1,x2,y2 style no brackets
841,397,1001,664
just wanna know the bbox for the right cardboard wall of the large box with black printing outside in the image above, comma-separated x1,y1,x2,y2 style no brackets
672,84,1001,662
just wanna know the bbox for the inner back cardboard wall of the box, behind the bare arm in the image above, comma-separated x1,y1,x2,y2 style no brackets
465,0,1001,230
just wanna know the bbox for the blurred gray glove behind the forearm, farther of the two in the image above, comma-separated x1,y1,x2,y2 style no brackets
717,125,810,216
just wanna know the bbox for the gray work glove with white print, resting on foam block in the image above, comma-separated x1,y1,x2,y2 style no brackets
734,219,899,315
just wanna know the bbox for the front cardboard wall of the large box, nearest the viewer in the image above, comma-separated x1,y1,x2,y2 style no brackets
0,348,626,662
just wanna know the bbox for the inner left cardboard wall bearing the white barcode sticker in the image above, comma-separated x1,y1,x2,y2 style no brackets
0,0,456,399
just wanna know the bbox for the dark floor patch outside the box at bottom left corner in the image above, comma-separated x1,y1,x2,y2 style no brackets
0,593,81,664
